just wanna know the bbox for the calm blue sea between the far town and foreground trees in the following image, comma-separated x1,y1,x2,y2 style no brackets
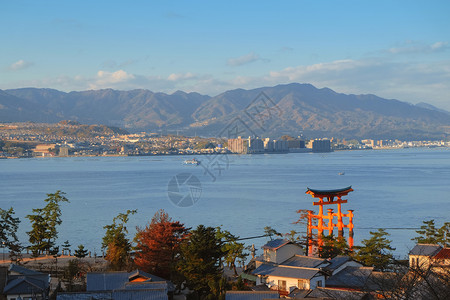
0,148,450,258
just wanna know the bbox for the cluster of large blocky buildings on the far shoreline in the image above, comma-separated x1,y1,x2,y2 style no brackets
228,137,332,154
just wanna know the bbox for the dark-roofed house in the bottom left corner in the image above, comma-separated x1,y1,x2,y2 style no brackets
3,264,50,300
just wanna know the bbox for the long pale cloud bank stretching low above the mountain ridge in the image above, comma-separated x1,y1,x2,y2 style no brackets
6,54,450,111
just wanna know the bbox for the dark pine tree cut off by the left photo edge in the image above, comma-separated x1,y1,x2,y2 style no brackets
0,207,21,261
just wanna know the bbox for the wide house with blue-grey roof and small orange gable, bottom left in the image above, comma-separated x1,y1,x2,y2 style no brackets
57,270,175,300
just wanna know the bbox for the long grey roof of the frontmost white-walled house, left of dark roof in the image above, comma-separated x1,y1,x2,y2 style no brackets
253,264,320,279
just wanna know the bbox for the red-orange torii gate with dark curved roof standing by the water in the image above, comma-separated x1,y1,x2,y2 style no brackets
306,186,353,253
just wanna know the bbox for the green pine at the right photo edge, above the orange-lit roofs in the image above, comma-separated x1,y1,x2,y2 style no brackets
412,220,450,247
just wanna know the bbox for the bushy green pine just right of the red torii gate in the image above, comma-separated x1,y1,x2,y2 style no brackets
354,228,395,271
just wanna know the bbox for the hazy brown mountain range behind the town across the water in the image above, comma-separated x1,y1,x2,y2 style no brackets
0,83,450,140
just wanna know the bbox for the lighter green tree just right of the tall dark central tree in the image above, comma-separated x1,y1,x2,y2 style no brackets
216,227,248,276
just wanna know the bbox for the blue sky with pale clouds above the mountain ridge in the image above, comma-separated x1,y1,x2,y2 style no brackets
0,0,450,111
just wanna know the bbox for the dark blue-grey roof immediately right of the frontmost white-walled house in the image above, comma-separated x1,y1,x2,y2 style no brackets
325,266,373,288
